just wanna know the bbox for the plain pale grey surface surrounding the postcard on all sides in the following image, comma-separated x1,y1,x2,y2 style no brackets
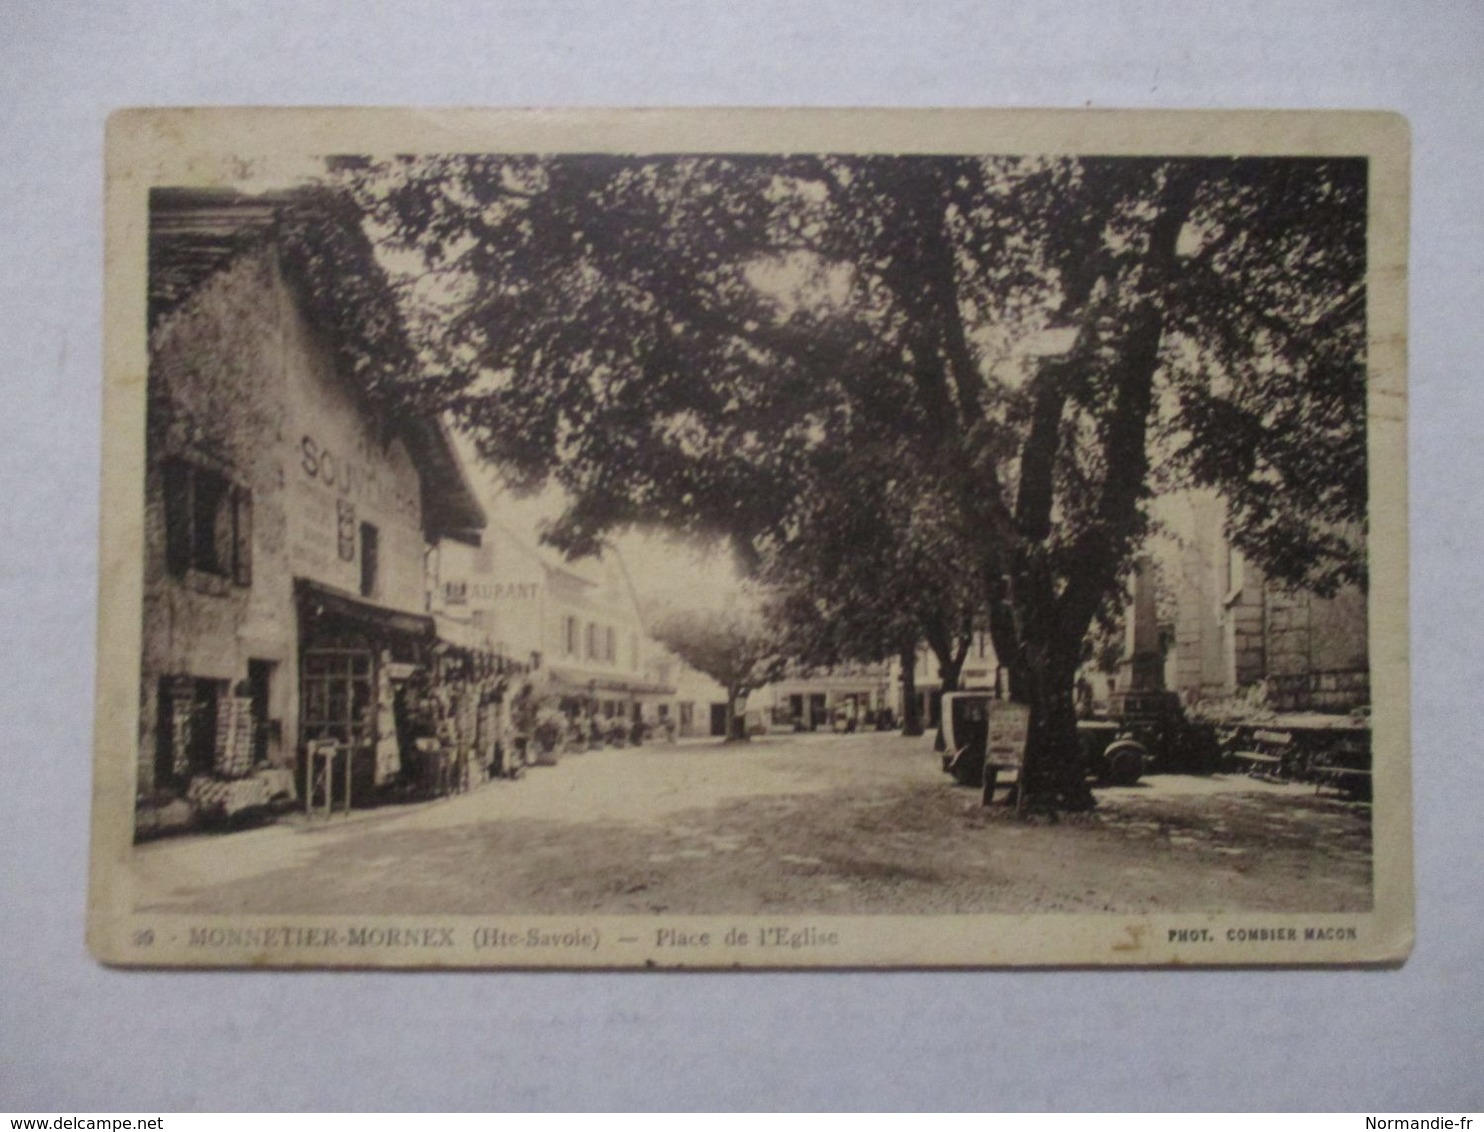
0,0,1484,1113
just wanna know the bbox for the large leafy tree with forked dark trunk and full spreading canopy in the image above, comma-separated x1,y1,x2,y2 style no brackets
339,156,1365,806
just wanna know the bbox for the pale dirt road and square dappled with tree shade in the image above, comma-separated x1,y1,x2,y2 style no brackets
134,734,1371,914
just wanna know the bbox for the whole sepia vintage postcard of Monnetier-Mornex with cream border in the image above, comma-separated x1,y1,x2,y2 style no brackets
88,108,1413,967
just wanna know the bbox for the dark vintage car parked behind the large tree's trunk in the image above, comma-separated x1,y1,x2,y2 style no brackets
942,691,1150,786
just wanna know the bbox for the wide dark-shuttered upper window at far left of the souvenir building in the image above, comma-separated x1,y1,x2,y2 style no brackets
165,460,252,586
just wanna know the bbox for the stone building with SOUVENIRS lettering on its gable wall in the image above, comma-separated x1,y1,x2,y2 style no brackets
137,188,484,829
